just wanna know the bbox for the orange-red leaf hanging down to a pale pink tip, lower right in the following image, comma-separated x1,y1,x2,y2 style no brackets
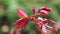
34,19,47,34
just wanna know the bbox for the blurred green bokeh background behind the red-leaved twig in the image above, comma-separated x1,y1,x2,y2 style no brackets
0,0,60,34
